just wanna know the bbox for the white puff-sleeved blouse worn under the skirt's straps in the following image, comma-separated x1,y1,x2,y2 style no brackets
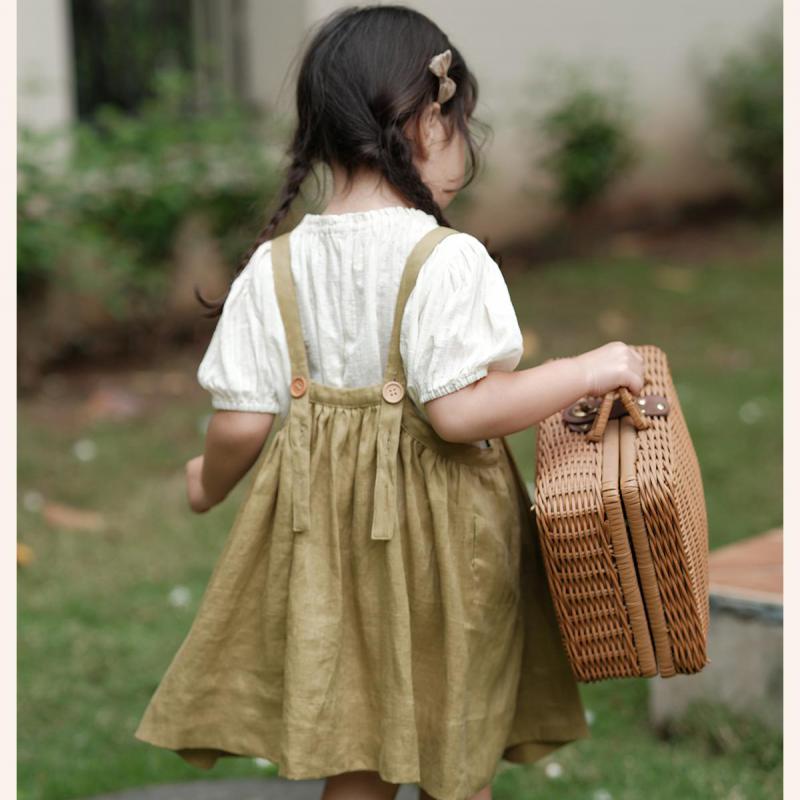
197,206,522,434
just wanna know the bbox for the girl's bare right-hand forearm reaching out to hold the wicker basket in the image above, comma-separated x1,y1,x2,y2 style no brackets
425,341,644,442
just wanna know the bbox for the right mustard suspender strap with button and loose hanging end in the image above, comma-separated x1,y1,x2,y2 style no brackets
370,225,458,539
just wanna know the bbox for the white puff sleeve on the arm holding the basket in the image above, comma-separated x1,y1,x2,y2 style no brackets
400,232,523,404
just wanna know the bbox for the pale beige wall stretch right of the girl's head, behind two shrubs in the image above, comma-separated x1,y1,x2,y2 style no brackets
294,0,780,239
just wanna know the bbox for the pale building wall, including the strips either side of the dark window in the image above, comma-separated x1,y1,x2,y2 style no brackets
18,0,780,240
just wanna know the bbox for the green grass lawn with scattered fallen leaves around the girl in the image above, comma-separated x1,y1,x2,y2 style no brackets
18,219,782,800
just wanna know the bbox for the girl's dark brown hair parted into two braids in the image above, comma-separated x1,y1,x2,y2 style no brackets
195,5,490,317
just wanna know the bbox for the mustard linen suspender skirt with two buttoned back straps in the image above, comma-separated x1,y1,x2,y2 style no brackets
134,227,589,800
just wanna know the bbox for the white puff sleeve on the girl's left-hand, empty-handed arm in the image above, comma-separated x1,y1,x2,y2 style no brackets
197,243,282,414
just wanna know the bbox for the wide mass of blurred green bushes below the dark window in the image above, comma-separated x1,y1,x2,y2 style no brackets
18,70,288,316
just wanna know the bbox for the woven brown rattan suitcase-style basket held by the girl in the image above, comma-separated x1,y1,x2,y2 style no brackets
533,345,710,682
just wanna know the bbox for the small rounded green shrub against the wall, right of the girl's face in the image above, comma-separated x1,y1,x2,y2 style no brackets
539,66,636,211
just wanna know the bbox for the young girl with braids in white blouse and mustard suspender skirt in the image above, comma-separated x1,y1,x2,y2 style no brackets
135,5,643,800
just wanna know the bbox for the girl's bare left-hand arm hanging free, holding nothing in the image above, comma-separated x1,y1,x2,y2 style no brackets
186,411,275,513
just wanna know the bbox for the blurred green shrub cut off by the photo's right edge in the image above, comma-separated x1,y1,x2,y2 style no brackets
703,21,783,205
